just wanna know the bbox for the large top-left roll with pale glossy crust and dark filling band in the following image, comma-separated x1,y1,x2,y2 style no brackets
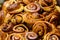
3,0,23,14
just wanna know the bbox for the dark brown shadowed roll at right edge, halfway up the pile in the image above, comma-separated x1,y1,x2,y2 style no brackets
45,10,60,25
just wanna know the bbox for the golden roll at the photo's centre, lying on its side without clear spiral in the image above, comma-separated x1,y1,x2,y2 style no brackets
23,12,41,24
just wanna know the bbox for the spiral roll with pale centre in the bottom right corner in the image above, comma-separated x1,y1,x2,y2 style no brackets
43,30,60,40
